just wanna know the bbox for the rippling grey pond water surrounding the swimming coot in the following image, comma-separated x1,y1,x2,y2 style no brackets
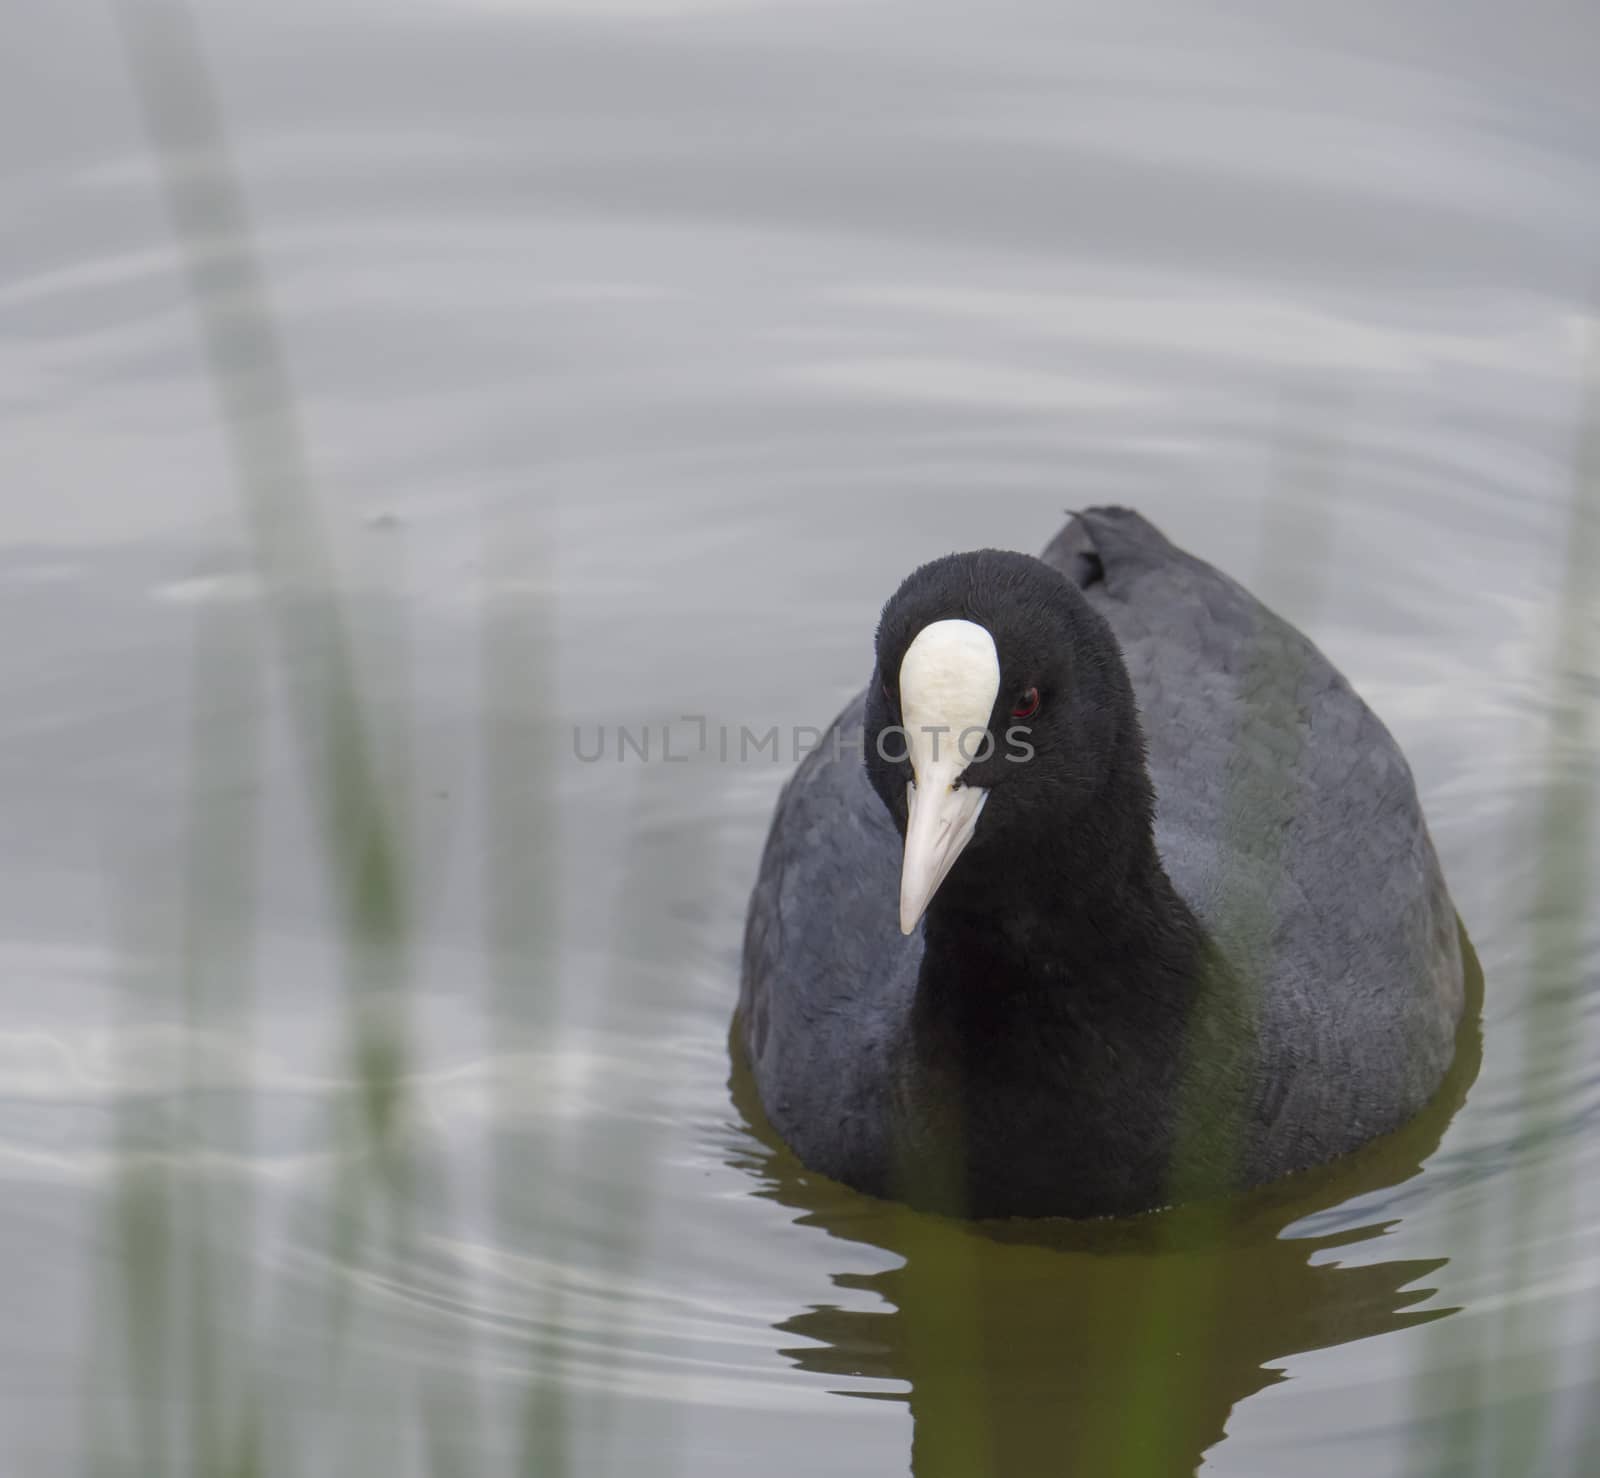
0,0,1600,1478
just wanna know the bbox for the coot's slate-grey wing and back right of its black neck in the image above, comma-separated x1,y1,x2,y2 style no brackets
1043,509,1462,1163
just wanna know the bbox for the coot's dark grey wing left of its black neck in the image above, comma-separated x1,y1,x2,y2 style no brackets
739,694,922,1188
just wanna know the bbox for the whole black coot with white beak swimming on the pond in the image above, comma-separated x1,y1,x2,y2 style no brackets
734,509,1462,1217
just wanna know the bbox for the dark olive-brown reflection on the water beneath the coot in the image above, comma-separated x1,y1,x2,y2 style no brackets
730,934,1483,1478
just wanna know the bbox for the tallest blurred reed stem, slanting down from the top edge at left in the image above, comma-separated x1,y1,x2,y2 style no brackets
112,0,410,1185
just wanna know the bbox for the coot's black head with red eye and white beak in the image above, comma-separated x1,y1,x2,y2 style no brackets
864,549,1147,934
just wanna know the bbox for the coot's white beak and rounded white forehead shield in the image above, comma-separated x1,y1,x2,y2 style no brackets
899,621,1000,934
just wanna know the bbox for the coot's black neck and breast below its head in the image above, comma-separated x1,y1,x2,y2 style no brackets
899,780,1213,1214
